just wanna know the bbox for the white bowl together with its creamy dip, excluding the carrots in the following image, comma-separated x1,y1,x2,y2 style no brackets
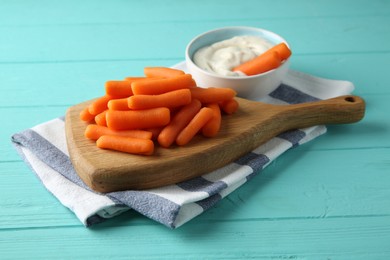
185,27,290,100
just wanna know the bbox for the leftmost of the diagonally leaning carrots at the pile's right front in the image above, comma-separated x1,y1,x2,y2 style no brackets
157,99,202,148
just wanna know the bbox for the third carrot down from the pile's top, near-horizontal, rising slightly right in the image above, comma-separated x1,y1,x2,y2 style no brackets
127,89,191,109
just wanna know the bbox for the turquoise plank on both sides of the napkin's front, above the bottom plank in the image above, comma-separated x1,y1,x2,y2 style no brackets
0,146,390,231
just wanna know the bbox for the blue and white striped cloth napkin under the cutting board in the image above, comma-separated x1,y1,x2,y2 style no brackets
12,63,354,228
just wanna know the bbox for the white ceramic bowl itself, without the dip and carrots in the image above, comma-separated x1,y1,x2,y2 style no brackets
185,27,290,100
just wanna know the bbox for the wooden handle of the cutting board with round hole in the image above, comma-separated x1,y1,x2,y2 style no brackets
268,95,365,129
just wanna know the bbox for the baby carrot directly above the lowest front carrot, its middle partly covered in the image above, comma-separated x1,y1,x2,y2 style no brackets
84,124,152,140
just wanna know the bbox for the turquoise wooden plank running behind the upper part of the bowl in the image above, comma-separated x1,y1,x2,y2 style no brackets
0,16,390,63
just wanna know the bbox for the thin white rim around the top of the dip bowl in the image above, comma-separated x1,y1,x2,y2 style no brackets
185,26,290,80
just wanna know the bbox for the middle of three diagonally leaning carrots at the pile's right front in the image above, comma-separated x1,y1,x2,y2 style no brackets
176,107,214,145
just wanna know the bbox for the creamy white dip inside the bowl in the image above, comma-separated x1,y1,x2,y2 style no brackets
193,35,273,76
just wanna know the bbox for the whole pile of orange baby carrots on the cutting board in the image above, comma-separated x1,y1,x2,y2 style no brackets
80,67,238,155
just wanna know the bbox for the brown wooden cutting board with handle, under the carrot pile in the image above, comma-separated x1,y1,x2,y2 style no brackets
65,95,365,192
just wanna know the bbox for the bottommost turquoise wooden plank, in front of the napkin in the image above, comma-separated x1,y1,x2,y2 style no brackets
0,216,390,259
